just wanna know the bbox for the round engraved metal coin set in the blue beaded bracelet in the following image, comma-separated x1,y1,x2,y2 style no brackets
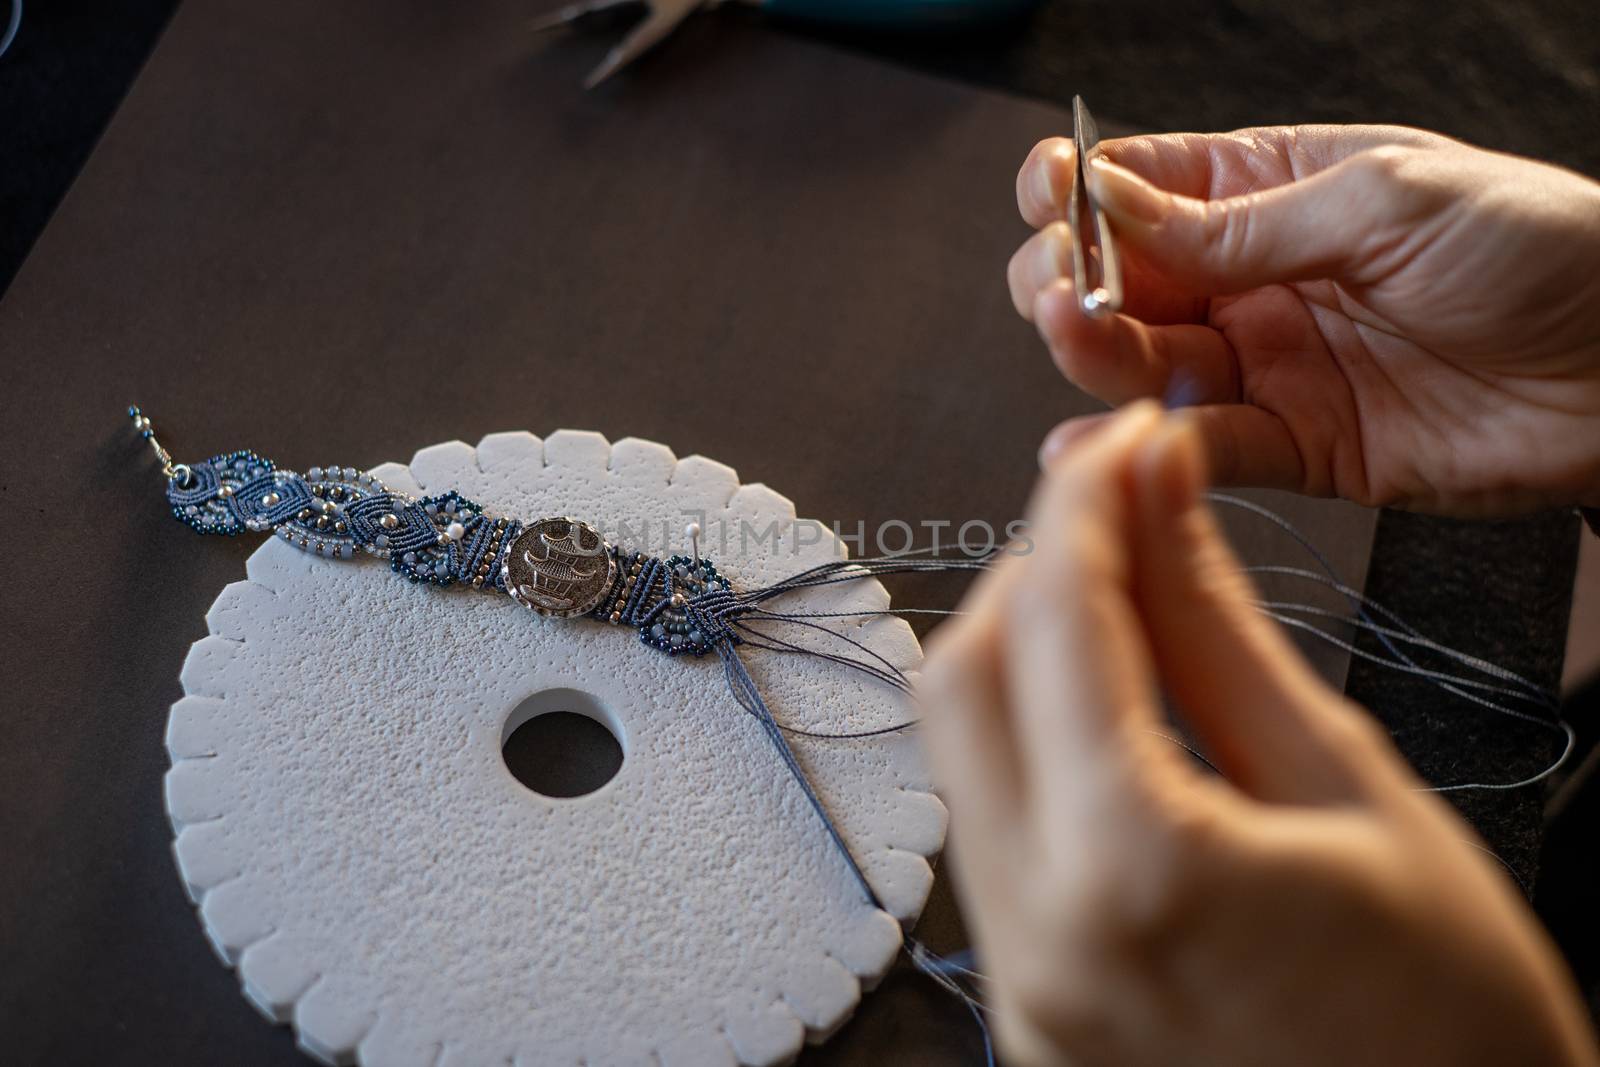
501,518,616,619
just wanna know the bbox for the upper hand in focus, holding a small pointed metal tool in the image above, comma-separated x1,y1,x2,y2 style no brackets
1010,126,1600,515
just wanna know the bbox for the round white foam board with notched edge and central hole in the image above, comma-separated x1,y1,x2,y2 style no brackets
166,430,946,1067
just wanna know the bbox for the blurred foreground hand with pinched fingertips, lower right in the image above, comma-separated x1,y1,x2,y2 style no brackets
922,403,1595,1067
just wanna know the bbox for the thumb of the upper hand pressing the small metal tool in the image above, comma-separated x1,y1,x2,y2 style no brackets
1088,146,1427,296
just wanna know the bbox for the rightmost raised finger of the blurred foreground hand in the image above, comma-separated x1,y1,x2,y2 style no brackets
1131,416,1390,805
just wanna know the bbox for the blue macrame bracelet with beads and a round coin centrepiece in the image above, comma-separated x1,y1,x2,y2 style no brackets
139,406,736,656
